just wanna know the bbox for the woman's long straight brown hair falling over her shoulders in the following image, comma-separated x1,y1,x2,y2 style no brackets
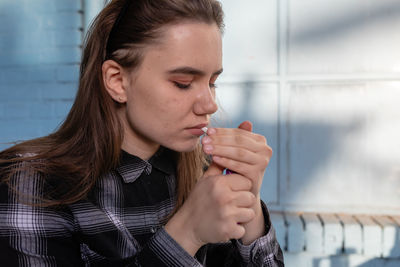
0,0,223,208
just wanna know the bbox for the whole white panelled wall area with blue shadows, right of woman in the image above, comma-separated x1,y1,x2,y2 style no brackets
217,0,400,214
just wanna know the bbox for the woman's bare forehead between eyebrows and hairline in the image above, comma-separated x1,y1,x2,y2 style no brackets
143,22,222,69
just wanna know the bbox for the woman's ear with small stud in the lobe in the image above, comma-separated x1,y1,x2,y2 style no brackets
101,60,127,103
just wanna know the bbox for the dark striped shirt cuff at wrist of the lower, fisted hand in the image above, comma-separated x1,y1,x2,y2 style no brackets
140,228,201,267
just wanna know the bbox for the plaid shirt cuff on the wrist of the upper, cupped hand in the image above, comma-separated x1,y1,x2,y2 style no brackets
235,201,281,266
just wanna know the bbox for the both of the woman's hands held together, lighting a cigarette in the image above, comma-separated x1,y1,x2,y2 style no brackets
166,121,272,255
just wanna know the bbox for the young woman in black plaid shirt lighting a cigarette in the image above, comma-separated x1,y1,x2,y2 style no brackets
0,0,283,266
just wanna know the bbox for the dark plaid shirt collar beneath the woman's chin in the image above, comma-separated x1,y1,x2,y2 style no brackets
116,147,178,183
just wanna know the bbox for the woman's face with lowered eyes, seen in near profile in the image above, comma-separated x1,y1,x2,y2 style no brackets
123,22,222,157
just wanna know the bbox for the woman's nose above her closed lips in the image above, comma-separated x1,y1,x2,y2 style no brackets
193,85,218,115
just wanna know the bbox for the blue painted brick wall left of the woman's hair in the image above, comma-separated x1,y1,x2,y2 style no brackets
0,0,82,149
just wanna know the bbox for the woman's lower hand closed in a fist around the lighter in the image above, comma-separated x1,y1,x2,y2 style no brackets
165,164,257,256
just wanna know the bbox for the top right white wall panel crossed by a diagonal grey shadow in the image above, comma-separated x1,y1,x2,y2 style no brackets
287,0,400,74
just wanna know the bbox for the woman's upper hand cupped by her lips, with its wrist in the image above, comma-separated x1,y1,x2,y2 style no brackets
202,121,272,244
